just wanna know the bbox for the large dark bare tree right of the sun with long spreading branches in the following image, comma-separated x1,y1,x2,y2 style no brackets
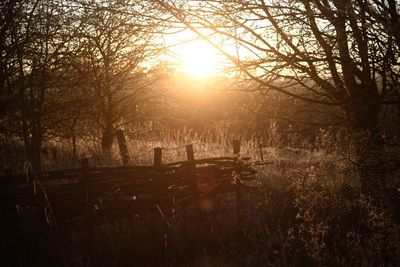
156,0,399,197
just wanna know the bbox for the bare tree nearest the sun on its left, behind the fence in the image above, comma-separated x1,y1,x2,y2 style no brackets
73,1,158,161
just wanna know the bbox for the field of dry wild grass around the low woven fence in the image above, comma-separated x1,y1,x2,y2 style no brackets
2,128,400,266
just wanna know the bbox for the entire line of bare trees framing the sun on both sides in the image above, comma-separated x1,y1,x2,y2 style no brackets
0,0,400,201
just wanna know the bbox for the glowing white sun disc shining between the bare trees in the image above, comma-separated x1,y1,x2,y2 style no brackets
178,40,221,78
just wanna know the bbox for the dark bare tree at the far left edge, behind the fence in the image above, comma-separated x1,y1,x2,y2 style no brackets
1,0,79,170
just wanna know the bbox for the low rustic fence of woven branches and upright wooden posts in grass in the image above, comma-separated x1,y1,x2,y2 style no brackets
0,141,256,230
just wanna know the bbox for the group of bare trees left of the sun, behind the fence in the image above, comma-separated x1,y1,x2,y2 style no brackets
0,0,167,170
